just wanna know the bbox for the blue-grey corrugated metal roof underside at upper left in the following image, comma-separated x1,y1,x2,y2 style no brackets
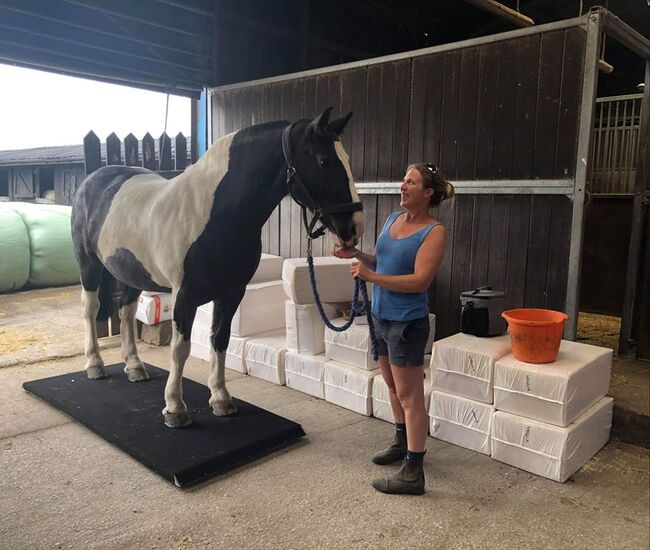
0,0,214,96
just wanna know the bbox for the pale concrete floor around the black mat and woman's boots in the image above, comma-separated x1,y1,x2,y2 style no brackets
0,289,650,549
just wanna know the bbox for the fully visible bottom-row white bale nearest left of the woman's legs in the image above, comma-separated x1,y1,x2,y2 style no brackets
323,361,377,416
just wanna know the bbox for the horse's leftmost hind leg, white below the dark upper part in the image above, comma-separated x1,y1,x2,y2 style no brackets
78,254,106,380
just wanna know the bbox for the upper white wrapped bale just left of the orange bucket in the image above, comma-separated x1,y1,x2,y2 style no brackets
431,332,511,403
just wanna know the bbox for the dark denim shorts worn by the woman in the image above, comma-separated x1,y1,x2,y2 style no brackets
372,315,429,367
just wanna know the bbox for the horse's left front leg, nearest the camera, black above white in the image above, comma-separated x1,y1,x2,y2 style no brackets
162,289,196,428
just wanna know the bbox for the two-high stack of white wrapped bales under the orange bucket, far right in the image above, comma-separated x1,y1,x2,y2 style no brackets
492,340,613,482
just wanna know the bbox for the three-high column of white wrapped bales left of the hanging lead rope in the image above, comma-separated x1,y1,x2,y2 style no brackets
282,257,354,399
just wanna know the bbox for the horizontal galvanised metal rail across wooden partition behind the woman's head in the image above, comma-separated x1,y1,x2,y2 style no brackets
355,179,575,196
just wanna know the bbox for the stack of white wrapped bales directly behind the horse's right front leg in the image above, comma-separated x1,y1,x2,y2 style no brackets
190,254,286,384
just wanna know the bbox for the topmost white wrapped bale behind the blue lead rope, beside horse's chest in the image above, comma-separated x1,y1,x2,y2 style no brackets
282,256,364,304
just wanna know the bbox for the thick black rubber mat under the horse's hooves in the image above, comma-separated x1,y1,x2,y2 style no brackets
23,363,305,487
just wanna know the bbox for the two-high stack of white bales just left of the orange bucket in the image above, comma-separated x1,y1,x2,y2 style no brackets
429,333,511,456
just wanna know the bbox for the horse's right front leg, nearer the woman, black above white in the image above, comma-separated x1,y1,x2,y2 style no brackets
208,287,246,416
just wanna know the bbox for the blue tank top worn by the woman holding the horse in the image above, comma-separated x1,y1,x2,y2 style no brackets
372,212,440,321
